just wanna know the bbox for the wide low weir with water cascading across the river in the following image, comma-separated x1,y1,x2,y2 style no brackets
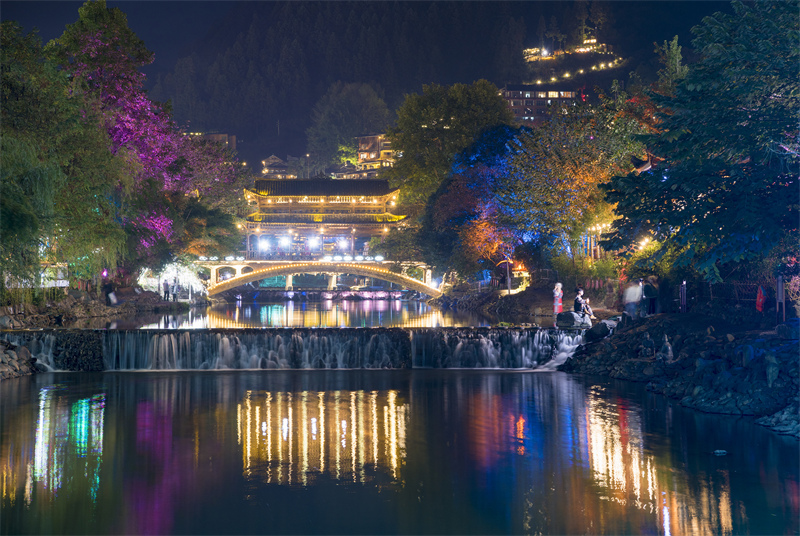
4,328,583,371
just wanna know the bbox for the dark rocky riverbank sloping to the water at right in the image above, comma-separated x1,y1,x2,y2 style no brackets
559,313,800,439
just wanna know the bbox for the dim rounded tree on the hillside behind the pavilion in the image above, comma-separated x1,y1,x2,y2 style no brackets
306,82,389,171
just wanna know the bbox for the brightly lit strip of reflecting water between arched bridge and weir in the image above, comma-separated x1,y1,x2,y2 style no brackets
141,300,490,329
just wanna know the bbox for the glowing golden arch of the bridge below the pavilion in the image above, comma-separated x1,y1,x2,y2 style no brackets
207,261,442,298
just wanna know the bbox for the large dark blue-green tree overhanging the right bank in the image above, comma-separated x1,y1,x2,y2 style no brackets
607,2,800,281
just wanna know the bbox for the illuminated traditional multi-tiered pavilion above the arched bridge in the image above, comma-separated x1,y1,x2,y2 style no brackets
245,179,405,258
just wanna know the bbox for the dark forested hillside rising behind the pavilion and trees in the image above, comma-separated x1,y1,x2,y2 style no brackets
151,2,530,163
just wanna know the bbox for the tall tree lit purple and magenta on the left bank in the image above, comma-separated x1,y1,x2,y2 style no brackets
46,0,241,272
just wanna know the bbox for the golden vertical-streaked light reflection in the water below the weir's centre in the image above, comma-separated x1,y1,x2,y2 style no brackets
237,390,408,486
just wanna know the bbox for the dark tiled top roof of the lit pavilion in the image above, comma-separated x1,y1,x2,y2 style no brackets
251,179,397,197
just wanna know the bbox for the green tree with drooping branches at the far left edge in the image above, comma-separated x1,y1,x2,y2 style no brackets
0,22,126,279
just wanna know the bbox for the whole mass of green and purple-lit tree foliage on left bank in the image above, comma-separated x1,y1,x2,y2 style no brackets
0,1,247,281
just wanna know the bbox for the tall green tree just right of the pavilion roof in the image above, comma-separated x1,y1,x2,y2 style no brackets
386,80,514,204
